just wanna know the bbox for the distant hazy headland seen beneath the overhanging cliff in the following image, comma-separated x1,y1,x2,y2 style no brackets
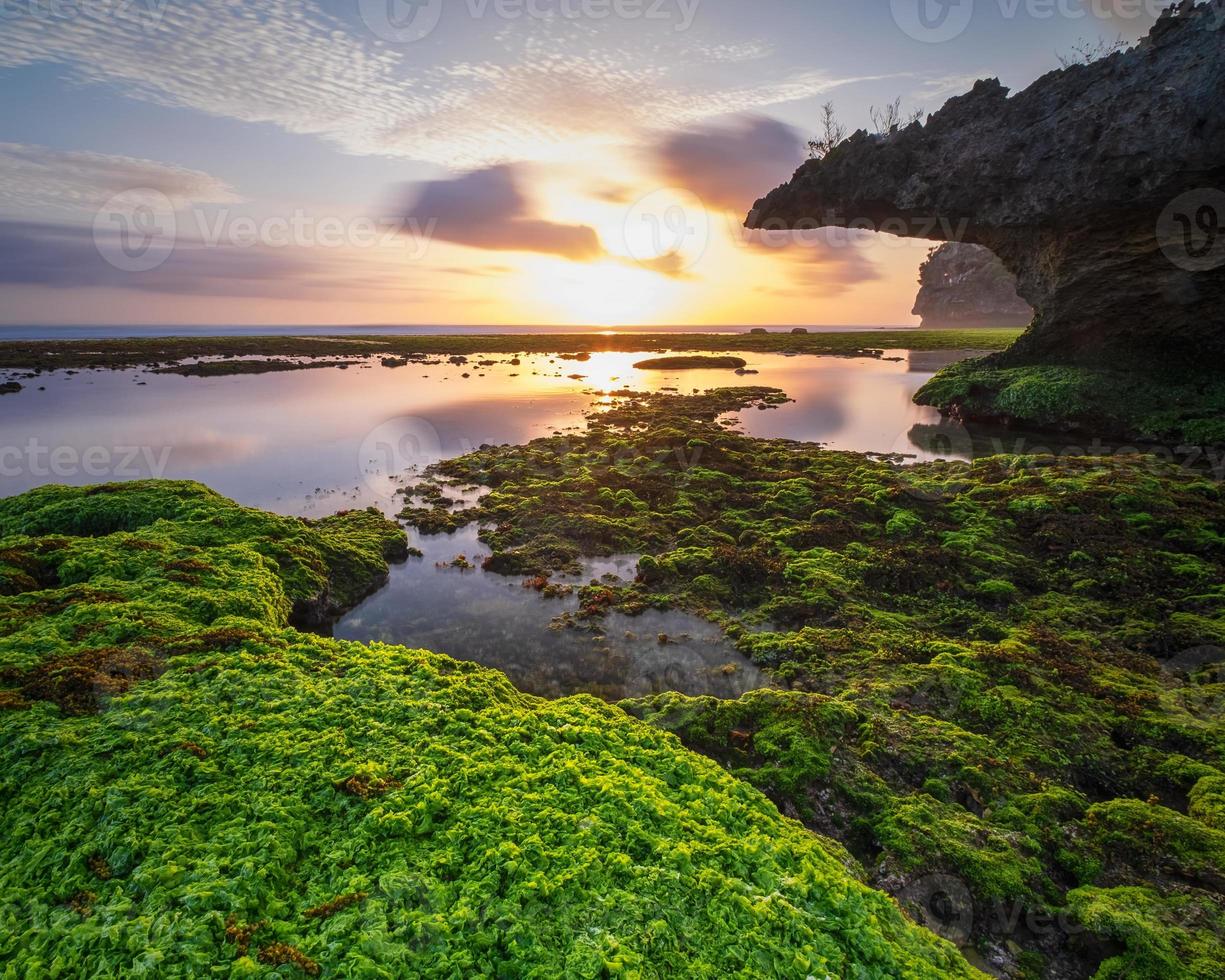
914,241,1034,328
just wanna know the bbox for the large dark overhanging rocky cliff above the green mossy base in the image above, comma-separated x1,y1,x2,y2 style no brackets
748,0,1225,371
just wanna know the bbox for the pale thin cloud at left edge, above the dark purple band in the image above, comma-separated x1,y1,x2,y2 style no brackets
0,143,240,213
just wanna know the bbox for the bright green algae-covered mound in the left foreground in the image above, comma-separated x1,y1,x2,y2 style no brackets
0,481,974,978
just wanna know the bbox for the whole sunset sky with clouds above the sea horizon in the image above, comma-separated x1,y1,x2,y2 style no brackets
0,0,1160,327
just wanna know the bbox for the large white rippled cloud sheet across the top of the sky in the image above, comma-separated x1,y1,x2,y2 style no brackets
0,0,872,168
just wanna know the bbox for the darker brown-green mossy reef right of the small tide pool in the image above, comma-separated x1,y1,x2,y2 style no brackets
435,388,1225,978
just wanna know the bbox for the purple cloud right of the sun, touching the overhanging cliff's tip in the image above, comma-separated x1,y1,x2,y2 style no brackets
653,115,805,214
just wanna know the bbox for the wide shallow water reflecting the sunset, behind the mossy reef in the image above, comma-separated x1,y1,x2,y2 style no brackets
0,352,970,516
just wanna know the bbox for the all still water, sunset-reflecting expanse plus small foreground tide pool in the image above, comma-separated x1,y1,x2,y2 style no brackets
0,352,971,699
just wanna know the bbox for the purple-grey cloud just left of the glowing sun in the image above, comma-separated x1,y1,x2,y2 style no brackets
397,164,605,262
